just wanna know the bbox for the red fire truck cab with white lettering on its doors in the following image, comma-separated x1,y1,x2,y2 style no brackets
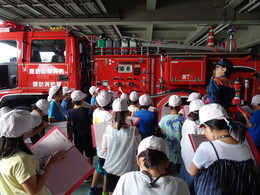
0,21,91,107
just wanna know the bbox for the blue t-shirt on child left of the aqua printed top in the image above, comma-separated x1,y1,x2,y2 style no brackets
135,110,158,133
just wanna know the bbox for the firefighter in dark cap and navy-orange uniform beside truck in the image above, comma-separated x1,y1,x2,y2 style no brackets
204,58,235,110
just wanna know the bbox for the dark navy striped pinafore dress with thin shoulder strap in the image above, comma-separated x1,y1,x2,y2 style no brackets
194,143,260,195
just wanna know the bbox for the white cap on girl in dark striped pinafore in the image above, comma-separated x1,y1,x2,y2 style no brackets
199,103,229,127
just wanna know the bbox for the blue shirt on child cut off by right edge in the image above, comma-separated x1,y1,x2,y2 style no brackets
249,110,260,146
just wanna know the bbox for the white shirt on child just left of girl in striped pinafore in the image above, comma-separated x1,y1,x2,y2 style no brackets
181,119,204,172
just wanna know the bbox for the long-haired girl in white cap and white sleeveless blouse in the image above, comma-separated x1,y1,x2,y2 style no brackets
102,98,140,194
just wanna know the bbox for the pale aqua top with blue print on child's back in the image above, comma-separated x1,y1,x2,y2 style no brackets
159,114,184,164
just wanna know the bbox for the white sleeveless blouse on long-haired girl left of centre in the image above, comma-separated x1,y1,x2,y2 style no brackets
102,126,141,176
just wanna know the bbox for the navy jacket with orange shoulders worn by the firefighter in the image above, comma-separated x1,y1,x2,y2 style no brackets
205,76,235,110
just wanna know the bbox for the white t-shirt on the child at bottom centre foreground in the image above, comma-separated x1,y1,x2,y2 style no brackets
113,171,190,195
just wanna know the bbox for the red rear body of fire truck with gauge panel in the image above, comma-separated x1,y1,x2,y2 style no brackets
93,48,260,108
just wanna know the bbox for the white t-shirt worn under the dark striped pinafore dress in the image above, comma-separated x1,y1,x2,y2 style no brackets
193,140,252,169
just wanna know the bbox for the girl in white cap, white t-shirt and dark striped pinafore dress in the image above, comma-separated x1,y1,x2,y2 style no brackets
190,104,260,195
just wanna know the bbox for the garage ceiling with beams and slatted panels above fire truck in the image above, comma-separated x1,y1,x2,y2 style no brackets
0,0,260,49
